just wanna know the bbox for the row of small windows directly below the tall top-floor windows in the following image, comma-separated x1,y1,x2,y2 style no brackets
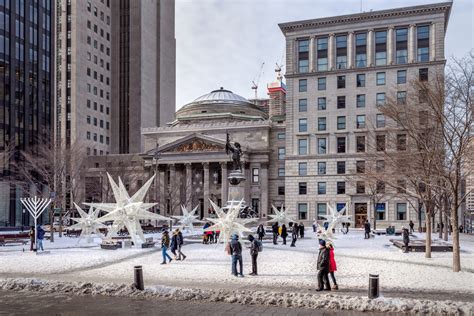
298,68,428,92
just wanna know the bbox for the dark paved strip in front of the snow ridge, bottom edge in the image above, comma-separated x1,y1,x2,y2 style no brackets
0,291,402,316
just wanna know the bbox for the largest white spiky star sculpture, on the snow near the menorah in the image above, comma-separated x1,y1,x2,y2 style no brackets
84,173,171,245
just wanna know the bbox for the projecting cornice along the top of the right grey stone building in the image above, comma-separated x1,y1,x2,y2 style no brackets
278,2,453,35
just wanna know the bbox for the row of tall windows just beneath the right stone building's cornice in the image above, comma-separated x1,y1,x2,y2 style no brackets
297,25,430,73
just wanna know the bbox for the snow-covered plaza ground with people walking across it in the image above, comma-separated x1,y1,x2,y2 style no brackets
0,229,474,315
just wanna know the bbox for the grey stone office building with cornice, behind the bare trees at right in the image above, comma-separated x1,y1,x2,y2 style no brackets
280,2,452,227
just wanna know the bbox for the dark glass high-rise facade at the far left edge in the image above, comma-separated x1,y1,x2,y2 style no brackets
0,0,54,226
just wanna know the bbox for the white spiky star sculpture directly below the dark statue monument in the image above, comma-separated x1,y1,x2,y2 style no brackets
204,199,254,245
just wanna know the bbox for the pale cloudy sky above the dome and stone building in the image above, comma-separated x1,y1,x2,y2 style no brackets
175,0,474,109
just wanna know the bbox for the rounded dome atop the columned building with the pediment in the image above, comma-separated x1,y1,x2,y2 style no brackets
176,87,267,121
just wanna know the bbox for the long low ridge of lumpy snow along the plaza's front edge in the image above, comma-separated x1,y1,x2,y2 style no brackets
0,279,474,315
